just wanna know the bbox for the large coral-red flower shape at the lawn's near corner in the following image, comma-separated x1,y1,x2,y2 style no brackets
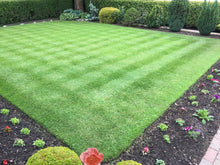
79,148,104,165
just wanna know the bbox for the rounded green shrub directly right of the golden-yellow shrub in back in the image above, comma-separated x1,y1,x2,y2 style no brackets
123,7,139,26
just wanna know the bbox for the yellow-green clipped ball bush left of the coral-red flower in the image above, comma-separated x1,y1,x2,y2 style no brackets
26,147,82,165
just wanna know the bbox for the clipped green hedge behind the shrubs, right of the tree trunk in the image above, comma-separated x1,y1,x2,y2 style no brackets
84,0,220,27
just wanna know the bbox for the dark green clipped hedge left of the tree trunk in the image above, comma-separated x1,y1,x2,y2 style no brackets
0,0,73,25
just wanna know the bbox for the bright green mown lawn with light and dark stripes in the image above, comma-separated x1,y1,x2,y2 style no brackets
0,21,220,160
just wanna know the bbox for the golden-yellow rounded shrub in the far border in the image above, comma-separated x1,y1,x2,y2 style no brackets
99,7,120,24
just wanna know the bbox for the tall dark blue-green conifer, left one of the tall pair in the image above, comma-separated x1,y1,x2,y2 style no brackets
168,0,188,32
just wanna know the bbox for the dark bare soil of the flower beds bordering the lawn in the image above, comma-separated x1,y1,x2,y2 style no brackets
0,22,220,165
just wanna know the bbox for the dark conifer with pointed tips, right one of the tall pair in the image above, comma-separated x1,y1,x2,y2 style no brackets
198,0,219,35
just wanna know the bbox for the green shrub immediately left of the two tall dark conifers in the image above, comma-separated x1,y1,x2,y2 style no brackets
143,5,162,28
